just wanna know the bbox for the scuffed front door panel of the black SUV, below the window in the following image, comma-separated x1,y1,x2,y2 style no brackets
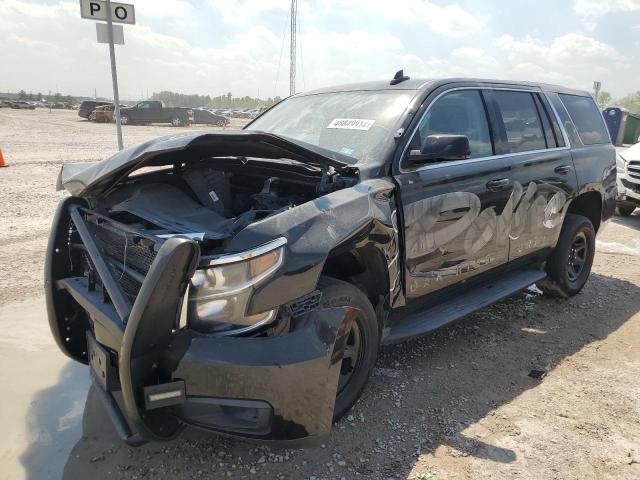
396,158,512,298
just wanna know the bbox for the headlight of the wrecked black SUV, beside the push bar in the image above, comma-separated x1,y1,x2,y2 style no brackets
188,238,287,335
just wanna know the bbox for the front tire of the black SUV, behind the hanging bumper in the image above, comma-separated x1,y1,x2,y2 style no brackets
318,277,380,421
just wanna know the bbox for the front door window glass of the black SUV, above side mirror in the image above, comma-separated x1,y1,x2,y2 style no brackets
411,90,493,158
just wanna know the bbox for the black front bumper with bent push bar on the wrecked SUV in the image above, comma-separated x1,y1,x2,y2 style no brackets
45,198,354,444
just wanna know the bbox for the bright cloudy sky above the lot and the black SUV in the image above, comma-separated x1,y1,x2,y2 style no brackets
0,0,640,99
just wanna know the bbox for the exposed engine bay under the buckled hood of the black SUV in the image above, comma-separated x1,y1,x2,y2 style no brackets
96,158,352,253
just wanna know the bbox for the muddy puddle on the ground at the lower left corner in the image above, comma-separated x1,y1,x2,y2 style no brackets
0,297,90,480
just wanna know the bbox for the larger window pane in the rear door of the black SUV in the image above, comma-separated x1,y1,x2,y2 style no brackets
493,90,547,153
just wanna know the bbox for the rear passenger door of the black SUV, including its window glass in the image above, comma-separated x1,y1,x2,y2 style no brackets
486,88,577,261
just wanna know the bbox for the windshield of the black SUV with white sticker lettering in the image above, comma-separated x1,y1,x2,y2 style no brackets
247,91,414,160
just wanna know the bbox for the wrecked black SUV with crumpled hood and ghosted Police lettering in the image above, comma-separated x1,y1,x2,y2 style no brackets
45,72,616,444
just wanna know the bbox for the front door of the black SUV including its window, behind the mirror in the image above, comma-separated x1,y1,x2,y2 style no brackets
395,87,512,299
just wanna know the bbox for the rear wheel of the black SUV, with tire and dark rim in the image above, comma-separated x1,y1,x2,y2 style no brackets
538,213,596,298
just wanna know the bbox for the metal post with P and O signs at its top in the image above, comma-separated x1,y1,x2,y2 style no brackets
80,0,136,150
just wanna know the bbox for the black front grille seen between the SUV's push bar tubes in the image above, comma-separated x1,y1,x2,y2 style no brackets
78,216,157,304
